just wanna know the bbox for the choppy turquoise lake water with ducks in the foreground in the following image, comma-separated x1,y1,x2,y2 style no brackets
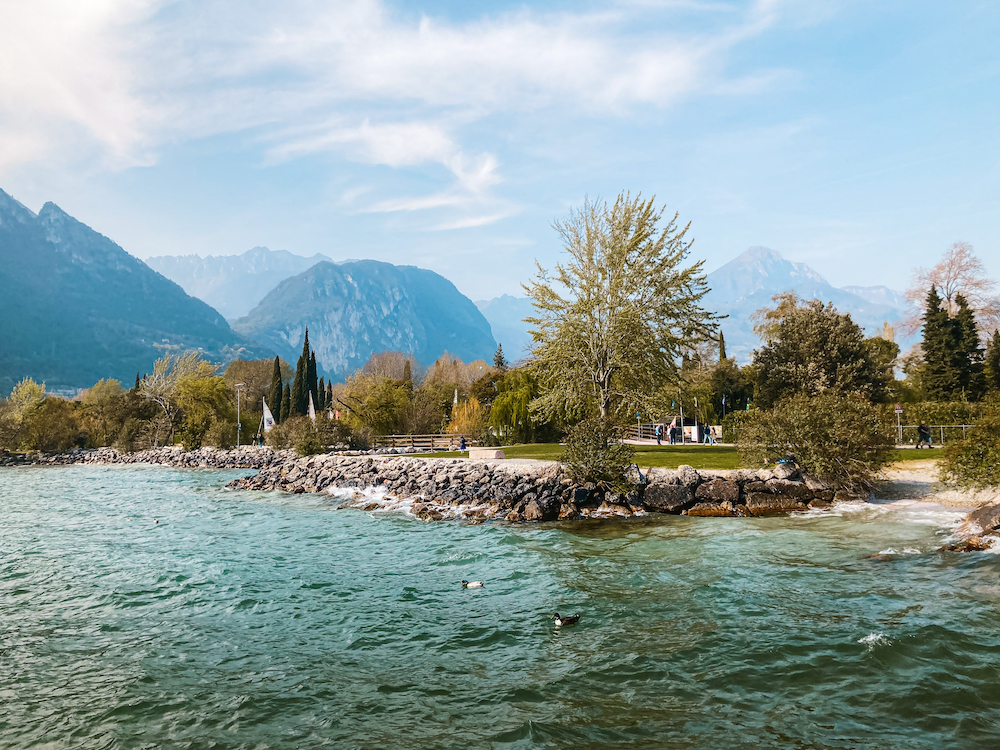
0,467,1000,749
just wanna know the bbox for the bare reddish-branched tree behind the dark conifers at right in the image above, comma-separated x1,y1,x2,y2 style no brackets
906,242,1000,335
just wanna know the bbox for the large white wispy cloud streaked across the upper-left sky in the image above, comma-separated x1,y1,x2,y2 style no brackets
0,0,801,228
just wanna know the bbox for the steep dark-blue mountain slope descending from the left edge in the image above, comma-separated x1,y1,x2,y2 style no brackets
0,190,268,394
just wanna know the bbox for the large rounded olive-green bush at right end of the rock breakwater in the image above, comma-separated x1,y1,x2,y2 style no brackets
736,394,895,494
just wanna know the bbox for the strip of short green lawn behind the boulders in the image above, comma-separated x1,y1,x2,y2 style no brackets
416,443,941,469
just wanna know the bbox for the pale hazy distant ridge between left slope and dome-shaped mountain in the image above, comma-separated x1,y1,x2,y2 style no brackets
146,247,333,320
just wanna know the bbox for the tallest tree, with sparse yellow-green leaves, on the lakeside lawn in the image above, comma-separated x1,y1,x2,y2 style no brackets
524,193,717,419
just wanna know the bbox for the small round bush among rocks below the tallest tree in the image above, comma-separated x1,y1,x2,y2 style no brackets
559,417,634,489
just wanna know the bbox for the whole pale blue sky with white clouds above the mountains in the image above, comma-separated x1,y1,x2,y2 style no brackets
0,0,1000,300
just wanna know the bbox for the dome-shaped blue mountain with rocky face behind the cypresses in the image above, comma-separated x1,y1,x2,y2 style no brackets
233,260,496,380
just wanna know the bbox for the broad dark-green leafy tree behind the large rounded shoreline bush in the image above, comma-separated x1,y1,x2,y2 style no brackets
753,292,892,409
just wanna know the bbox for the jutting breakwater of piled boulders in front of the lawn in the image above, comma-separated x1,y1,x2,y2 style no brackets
227,454,840,523
